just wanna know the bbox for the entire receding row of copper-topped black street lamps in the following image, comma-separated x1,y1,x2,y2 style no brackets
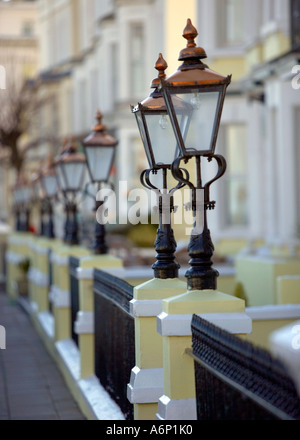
11,19,231,290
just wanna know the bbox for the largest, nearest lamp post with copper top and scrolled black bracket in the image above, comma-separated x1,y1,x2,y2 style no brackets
161,19,231,290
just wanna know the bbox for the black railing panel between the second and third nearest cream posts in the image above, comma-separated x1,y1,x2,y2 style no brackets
94,270,135,420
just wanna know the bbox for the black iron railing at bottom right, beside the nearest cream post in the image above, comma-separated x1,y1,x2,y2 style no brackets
192,315,300,420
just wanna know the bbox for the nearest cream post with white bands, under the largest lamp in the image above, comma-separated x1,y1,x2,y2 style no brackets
157,290,251,420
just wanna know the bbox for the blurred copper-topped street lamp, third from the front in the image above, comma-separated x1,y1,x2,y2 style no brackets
82,110,118,255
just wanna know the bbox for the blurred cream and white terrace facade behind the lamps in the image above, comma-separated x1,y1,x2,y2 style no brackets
14,0,300,256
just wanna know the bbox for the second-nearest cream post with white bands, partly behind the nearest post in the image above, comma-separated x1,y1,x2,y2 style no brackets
127,278,186,420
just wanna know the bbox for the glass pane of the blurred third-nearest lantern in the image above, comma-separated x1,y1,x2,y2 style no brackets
85,146,114,182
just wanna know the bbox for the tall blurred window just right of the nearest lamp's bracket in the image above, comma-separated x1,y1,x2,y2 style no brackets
220,125,248,227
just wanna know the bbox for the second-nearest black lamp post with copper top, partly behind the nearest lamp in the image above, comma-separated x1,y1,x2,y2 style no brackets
131,54,184,279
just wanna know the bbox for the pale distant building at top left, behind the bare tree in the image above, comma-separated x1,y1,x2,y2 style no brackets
0,0,39,220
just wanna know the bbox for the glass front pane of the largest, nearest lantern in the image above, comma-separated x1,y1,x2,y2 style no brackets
172,90,220,151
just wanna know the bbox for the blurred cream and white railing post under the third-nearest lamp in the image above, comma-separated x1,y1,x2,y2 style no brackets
74,255,123,379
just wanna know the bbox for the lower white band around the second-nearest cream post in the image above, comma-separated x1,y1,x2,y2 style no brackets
127,366,163,403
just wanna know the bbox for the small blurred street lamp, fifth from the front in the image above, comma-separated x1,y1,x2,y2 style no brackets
40,155,58,238
